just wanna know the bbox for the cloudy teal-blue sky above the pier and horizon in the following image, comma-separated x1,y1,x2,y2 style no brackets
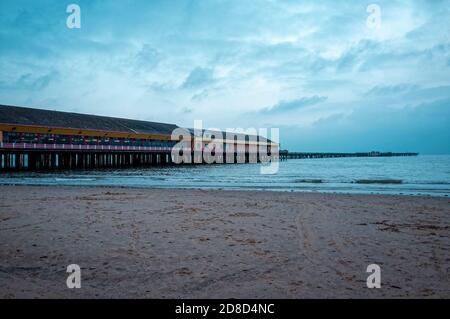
0,0,450,154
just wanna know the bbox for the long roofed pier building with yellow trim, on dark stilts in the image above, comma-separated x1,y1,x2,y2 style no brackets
0,105,278,171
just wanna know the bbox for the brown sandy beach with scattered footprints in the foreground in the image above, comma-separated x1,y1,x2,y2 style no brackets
0,186,450,298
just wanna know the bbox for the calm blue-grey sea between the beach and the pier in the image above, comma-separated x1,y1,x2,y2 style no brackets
0,155,450,197
